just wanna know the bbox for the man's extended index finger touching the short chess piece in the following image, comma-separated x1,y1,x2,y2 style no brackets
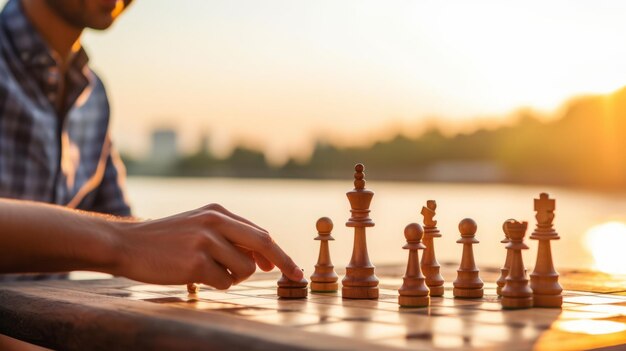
207,212,304,281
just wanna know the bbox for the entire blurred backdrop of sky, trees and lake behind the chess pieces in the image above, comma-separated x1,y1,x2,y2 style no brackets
8,0,626,274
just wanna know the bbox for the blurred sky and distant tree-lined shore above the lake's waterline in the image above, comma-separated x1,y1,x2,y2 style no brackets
79,0,626,190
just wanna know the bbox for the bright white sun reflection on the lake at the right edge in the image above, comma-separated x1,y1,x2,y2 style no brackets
585,222,626,274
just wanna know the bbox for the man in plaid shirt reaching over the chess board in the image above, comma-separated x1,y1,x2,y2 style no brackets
0,0,302,288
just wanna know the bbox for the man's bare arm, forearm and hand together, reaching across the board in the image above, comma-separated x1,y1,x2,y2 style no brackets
0,199,302,289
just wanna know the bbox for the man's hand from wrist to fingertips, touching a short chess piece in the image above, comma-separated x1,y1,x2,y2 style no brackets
114,204,302,289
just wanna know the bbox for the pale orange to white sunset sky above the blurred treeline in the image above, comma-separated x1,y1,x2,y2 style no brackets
7,0,626,162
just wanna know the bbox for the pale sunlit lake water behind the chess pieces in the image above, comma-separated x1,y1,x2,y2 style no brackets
127,177,626,272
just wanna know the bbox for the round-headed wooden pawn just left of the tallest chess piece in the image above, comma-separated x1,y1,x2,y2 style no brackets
311,217,339,292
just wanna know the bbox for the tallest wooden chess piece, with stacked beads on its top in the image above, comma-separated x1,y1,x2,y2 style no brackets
341,163,378,299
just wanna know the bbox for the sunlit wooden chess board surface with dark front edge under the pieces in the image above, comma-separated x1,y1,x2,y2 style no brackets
0,265,626,350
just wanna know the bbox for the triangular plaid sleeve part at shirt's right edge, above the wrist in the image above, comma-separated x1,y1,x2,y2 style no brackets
90,141,131,217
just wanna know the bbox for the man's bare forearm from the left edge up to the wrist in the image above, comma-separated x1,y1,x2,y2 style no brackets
0,199,121,273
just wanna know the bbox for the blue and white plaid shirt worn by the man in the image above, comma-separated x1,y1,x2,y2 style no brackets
0,0,130,216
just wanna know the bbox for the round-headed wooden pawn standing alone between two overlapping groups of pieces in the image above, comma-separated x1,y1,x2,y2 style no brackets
452,218,484,298
